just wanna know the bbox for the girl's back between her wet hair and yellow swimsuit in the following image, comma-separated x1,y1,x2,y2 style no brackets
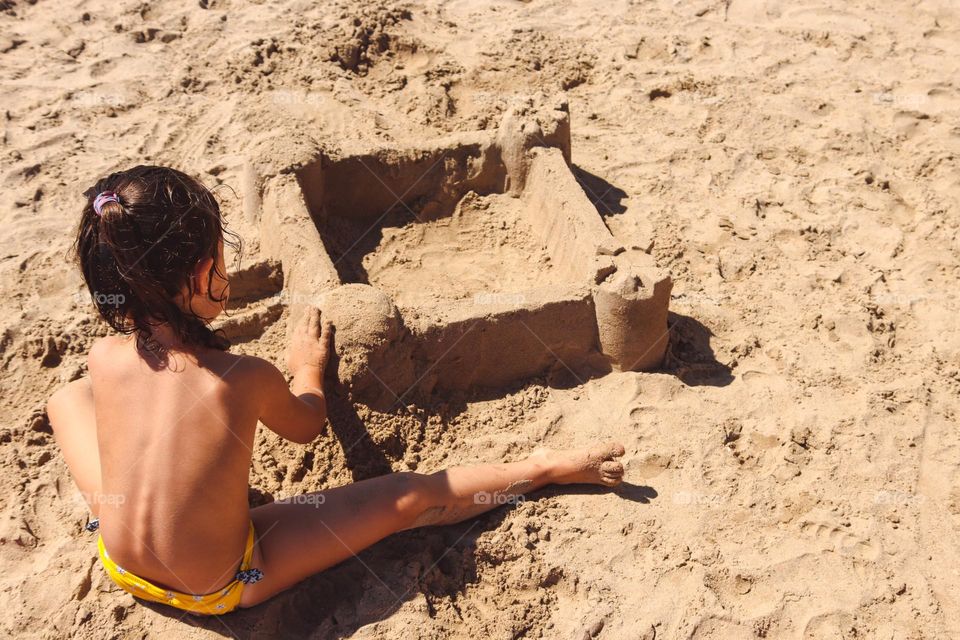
89,338,259,593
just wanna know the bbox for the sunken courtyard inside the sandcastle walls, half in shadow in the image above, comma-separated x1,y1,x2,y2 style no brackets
300,149,563,309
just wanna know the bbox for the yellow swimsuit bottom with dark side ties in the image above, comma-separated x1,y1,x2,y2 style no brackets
95,522,263,615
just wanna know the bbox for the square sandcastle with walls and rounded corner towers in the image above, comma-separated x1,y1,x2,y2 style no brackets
260,100,671,404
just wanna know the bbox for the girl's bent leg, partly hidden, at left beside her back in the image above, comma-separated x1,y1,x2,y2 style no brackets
47,376,102,517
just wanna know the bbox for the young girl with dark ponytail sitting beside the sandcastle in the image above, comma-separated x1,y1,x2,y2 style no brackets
47,166,623,614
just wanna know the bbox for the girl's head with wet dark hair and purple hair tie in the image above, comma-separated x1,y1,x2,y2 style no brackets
76,166,239,349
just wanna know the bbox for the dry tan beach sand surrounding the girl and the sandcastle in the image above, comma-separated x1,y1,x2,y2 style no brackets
0,0,960,639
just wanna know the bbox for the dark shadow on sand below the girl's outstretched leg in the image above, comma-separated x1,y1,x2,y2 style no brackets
146,482,657,640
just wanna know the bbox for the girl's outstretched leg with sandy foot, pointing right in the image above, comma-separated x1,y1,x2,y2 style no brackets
240,442,623,607
